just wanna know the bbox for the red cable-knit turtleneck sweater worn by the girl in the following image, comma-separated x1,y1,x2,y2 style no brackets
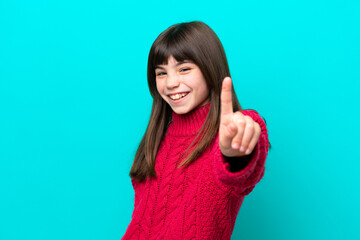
122,103,269,240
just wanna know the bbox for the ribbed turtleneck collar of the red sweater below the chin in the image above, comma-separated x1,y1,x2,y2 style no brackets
168,103,210,136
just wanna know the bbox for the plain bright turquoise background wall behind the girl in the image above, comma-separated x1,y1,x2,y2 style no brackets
0,0,360,240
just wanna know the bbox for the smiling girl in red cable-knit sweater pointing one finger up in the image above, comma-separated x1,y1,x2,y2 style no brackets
122,22,269,239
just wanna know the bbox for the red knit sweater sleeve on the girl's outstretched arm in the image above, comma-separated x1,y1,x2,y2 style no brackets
213,110,269,195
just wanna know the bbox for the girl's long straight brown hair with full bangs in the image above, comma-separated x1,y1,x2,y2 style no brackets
130,21,242,181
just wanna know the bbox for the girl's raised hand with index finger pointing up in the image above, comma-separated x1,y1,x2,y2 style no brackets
219,77,261,157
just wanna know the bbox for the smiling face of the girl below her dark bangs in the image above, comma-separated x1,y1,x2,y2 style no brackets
155,56,209,114
